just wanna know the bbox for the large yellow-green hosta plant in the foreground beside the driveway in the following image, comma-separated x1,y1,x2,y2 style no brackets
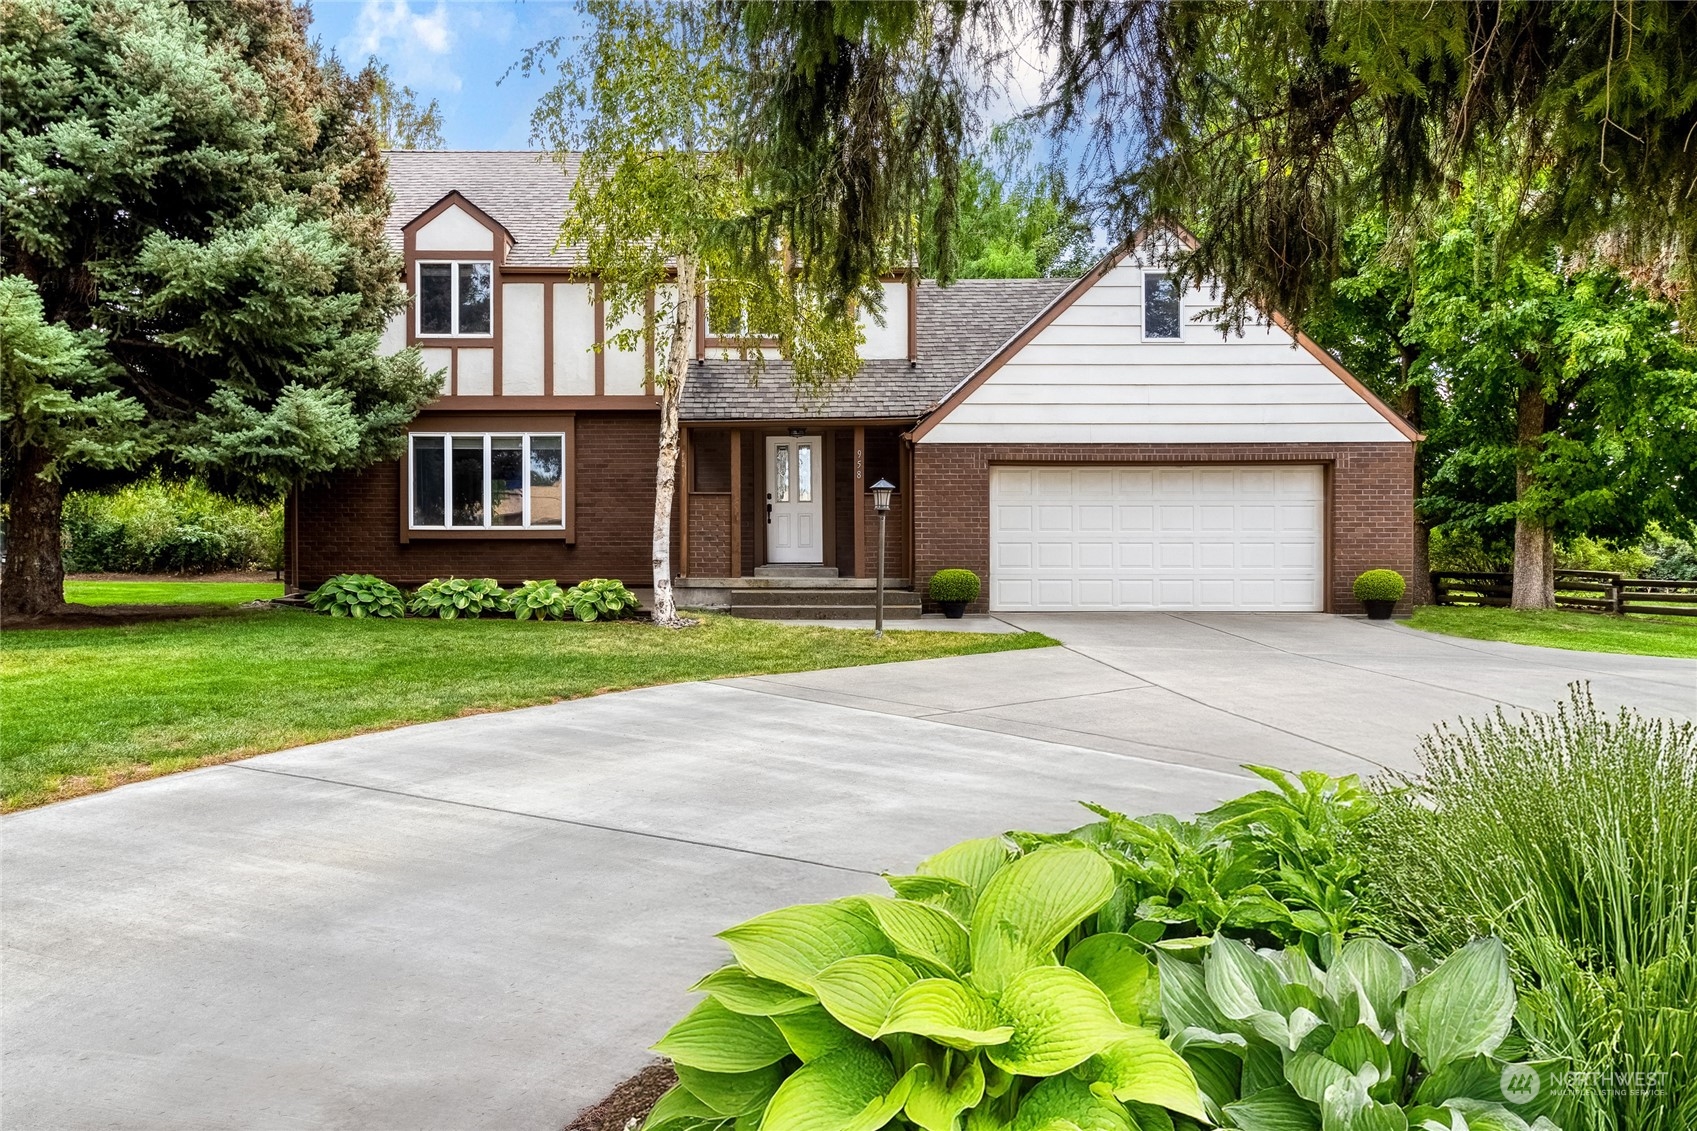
645,837,1207,1131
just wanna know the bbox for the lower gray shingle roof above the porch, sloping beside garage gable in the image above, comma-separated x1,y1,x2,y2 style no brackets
682,279,1073,421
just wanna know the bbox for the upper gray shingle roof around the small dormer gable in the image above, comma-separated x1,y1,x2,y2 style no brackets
384,149,577,267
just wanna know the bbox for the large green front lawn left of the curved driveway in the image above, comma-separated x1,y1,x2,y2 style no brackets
0,610,1054,810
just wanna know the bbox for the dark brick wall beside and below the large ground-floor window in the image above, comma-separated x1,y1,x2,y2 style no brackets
285,413,677,589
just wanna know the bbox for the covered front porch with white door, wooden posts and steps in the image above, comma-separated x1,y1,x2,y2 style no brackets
677,419,918,615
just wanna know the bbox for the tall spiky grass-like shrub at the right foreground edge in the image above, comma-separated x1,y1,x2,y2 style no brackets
1363,686,1697,1131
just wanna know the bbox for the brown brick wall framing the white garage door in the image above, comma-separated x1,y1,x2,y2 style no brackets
913,443,1414,613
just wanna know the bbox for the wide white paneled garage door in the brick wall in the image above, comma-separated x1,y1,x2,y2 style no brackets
989,464,1325,611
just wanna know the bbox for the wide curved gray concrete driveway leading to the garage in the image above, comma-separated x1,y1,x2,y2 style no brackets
0,615,1697,1129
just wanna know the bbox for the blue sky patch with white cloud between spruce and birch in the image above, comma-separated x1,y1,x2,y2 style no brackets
311,0,579,149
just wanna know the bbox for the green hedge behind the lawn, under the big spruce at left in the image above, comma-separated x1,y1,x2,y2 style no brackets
63,475,283,574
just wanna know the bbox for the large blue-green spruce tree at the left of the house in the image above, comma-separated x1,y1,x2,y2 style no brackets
0,0,434,615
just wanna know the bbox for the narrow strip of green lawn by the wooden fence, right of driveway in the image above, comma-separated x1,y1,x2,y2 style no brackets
1410,605,1697,657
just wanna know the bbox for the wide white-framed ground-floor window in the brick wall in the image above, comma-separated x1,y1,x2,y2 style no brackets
407,431,568,530
